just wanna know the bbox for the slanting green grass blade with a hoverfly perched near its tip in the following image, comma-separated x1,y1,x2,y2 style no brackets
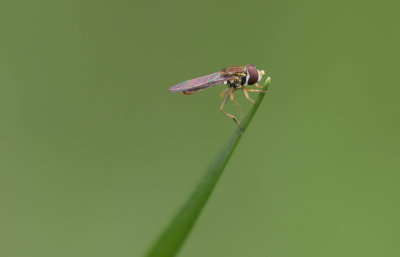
145,77,271,257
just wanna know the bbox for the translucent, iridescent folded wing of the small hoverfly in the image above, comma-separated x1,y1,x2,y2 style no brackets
169,72,231,93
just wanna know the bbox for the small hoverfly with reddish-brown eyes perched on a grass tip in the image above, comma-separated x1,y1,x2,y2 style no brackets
169,64,266,133
